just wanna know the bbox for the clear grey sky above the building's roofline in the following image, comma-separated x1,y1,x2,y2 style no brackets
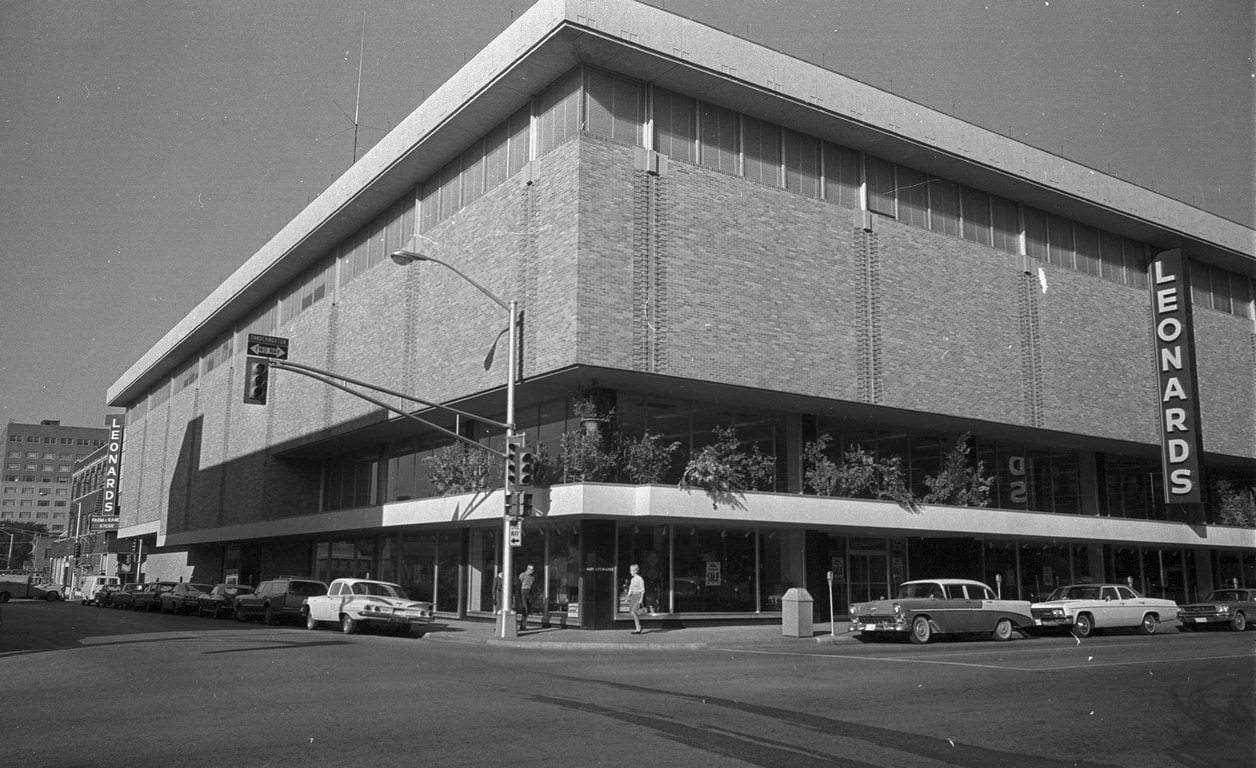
0,0,1256,425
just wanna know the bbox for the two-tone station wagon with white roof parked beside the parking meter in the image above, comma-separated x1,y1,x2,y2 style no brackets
850,578,1034,644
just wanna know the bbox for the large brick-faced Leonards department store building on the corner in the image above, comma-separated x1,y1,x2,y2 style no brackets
108,0,1256,626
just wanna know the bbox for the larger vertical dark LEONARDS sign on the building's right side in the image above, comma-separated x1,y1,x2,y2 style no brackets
1150,249,1203,504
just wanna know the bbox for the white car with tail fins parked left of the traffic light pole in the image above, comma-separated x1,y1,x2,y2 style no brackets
305,578,432,635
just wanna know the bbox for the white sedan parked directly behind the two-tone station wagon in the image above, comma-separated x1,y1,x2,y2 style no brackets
1030,583,1178,637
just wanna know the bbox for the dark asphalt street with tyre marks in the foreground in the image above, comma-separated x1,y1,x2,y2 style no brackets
0,602,1256,768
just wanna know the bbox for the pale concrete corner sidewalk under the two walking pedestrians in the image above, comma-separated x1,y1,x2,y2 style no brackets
423,617,854,651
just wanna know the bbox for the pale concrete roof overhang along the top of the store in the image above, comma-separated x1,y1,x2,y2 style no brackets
107,0,1256,406
